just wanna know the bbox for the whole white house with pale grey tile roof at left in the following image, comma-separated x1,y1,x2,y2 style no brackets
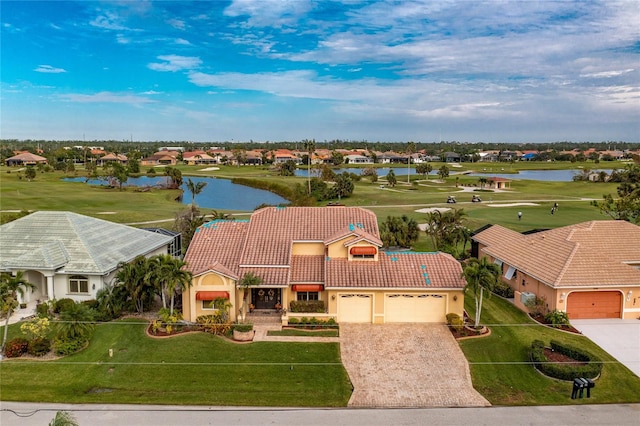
0,211,174,303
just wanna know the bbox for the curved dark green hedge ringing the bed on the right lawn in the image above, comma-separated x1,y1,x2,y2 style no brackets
530,340,602,381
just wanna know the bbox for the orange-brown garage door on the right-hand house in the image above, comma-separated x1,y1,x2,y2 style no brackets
567,291,622,319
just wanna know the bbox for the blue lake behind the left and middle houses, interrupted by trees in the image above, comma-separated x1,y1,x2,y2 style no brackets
64,176,289,211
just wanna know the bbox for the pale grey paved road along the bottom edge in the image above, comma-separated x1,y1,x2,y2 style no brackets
0,402,640,426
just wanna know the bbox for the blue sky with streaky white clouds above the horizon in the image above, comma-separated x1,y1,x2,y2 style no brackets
0,0,640,142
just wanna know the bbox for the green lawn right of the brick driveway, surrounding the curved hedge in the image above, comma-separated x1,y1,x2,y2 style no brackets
460,296,640,405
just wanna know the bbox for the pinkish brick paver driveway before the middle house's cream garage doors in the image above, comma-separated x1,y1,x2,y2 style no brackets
340,324,490,407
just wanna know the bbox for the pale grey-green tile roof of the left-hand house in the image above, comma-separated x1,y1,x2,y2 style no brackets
0,211,172,274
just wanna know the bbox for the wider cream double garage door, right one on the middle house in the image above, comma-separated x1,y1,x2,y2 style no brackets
384,293,447,322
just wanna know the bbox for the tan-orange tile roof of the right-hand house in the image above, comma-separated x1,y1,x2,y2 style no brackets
473,220,640,287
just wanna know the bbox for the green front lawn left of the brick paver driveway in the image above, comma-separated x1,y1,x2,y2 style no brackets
0,321,352,407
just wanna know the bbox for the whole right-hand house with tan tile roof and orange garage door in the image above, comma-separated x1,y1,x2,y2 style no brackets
472,220,640,319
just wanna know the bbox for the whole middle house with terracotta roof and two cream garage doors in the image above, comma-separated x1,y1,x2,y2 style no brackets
182,206,466,323
